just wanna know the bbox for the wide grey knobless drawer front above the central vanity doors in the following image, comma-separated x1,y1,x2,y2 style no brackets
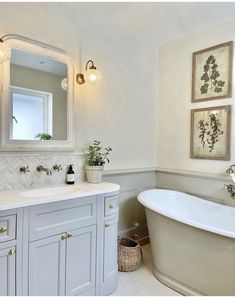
29,196,97,241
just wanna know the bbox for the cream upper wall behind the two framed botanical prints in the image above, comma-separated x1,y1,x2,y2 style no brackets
157,21,235,173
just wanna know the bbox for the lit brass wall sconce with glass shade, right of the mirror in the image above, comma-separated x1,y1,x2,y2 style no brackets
76,60,102,85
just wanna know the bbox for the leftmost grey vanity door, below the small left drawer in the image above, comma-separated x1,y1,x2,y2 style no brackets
0,247,16,296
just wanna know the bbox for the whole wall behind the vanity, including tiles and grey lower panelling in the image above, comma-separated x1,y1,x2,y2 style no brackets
0,3,157,233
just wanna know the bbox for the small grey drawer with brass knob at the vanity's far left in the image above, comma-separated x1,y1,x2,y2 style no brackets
0,215,16,242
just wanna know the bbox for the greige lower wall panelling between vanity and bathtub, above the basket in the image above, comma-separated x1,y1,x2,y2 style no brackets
103,172,156,237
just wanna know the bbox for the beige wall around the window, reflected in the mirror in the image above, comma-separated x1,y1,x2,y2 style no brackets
11,65,67,140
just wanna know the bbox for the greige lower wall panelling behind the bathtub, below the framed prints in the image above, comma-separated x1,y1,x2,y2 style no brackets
156,171,235,207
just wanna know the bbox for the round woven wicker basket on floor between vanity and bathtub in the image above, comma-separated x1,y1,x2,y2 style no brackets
118,238,143,272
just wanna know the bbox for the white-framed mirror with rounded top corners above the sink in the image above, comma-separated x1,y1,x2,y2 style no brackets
0,35,75,151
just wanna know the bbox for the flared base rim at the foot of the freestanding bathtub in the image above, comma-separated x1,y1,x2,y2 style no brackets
153,267,205,296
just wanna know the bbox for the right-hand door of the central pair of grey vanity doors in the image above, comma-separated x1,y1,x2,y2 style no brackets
66,225,96,296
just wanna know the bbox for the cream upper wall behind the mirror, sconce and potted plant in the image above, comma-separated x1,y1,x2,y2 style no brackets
0,3,157,169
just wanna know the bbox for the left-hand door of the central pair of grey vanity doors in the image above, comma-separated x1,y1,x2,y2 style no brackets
29,235,66,296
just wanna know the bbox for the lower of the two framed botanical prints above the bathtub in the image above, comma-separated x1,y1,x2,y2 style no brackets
190,105,231,160
